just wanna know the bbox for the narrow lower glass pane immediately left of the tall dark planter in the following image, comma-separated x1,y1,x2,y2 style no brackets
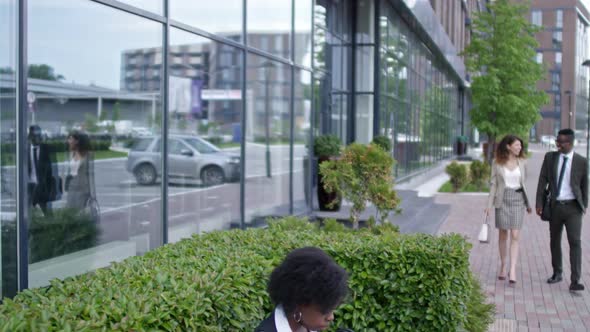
293,70,312,213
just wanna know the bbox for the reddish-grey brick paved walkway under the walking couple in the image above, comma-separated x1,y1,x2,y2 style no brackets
436,145,590,331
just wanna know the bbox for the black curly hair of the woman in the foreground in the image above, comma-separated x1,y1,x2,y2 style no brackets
268,247,348,315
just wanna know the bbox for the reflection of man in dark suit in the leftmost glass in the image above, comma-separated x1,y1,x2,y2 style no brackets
28,125,59,216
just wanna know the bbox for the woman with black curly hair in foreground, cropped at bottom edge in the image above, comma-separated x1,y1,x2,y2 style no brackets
255,247,348,332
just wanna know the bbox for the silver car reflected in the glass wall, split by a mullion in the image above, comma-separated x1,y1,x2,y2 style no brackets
127,135,240,186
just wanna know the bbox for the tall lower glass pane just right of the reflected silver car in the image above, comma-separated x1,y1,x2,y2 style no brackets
245,54,291,223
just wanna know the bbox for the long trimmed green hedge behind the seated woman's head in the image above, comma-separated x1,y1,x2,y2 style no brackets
0,218,490,332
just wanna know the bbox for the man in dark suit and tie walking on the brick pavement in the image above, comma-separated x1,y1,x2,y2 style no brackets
536,129,588,291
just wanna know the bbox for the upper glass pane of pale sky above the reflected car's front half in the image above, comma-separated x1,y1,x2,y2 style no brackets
169,0,244,41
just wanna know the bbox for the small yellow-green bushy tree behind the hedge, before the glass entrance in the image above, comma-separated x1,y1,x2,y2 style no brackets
320,143,400,229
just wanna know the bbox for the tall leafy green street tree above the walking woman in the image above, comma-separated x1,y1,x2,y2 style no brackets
464,0,548,160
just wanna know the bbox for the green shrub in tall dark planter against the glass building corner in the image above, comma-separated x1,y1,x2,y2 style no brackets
313,135,342,211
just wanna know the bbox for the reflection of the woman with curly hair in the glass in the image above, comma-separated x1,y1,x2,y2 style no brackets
65,131,96,210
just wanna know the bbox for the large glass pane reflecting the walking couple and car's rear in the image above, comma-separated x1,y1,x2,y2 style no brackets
27,0,163,287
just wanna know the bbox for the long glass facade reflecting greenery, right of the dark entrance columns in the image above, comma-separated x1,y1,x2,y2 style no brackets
379,1,459,177
